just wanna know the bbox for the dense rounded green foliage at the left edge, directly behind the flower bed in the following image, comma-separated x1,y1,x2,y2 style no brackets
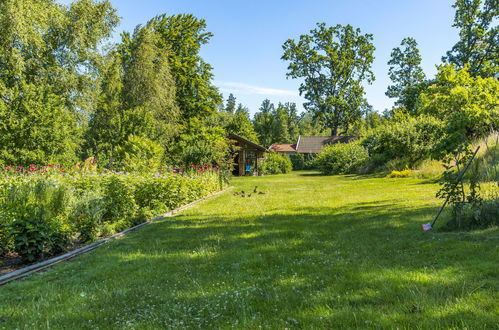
0,83,81,165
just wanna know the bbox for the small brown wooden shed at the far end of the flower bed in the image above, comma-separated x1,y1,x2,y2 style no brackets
229,134,267,176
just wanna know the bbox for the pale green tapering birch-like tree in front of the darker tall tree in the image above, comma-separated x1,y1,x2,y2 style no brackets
87,26,179,159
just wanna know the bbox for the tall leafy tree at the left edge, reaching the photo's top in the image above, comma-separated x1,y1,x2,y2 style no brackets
0,0,118,163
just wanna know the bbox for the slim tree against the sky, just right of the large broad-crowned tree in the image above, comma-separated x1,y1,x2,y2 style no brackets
385,38,425,113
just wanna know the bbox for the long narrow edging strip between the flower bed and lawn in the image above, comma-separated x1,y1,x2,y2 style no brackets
0,186,233,286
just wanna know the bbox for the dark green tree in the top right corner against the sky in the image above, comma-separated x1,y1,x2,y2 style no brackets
442,0,499,77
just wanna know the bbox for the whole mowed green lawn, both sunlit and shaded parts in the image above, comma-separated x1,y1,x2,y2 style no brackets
0,172,499,329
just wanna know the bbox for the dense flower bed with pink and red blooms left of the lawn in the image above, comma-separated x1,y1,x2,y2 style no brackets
0,162,226,262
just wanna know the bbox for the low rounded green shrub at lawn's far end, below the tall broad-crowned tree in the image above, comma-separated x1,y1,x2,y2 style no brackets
315,142,369,175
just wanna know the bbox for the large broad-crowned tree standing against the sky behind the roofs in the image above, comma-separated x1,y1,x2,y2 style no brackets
282,23,375,135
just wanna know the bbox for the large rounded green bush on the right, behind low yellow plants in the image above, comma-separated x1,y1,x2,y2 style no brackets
362,116,443,170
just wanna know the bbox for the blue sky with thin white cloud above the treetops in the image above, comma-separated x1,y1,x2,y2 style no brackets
62,0,458,113
